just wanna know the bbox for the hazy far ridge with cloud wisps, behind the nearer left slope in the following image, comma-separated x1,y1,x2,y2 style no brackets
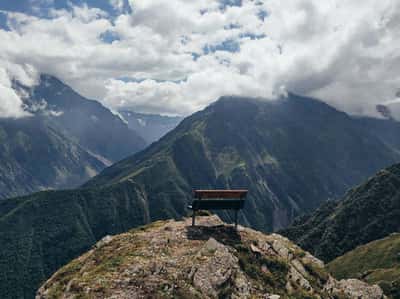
22,75,146,162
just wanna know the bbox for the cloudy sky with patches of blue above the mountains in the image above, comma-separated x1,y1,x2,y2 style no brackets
0,0,400,117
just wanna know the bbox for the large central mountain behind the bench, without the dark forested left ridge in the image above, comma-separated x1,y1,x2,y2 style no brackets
85,95,399,230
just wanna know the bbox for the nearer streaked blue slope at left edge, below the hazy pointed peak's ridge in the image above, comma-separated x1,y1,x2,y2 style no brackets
0,117,106,199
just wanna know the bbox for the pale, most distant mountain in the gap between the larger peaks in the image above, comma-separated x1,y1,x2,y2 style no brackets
119,110,183,144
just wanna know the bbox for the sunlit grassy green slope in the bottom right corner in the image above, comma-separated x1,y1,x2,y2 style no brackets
327,233,400,299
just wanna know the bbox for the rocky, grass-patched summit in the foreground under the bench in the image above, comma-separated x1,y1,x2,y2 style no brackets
36,216,385,299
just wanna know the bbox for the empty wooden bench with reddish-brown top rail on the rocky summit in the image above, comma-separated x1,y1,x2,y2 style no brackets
188,190,247,228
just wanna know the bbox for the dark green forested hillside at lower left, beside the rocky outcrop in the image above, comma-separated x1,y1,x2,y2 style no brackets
0,184,150,298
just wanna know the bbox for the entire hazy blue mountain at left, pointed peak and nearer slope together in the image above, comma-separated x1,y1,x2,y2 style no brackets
0,75,146,199
